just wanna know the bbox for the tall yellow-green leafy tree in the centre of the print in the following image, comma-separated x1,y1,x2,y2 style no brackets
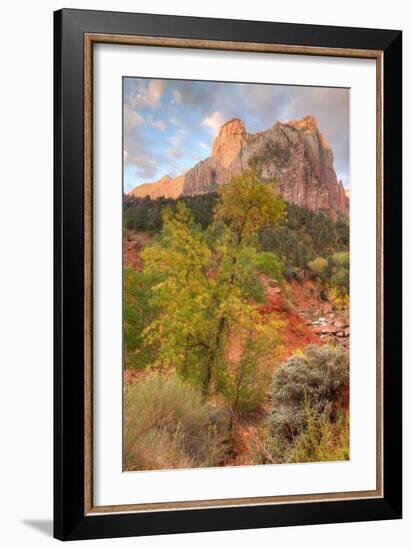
142,168,283,395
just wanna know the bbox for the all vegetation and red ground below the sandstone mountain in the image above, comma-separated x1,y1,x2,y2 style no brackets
123,163,349,470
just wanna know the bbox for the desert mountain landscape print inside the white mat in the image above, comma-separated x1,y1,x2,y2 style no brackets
122,77,350,471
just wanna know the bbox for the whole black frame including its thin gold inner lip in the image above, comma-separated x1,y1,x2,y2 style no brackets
54,9,402,540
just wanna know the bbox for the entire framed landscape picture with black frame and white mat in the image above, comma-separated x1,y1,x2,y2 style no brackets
54,10,402,540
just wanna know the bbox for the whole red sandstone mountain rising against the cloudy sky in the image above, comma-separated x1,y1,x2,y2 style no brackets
129,116,349,218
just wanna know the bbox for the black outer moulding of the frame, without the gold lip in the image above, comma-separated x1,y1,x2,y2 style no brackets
54,9,402,540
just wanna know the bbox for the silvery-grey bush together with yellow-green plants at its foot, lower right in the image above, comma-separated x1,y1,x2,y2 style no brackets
251,345,349,463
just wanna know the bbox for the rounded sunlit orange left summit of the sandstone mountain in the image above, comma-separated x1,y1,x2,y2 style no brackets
212,118,247,168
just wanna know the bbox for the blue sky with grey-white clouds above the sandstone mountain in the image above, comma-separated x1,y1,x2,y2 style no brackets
123,78,349,192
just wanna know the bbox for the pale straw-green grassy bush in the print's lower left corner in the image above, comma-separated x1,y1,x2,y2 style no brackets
123,374,228,470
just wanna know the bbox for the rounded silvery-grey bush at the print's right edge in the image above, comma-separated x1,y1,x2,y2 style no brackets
270,345,349,442
